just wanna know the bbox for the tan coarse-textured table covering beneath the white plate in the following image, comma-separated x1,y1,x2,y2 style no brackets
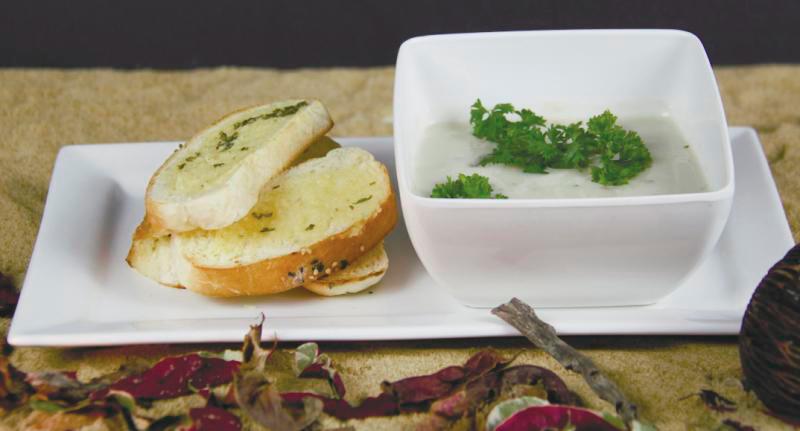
0,66,800,430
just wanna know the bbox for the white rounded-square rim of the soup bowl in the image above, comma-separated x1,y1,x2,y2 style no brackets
393,29,734,209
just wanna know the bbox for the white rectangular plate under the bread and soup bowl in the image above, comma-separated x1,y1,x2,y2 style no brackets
8,128,794,346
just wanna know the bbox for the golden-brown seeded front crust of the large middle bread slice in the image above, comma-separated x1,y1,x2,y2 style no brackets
181,189,397,297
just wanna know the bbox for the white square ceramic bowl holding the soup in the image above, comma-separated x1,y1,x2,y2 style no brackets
394,30,734,307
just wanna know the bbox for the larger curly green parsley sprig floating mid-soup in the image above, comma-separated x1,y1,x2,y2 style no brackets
470,99,653,186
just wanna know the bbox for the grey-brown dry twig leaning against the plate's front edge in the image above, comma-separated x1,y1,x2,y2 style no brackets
492,298,638,423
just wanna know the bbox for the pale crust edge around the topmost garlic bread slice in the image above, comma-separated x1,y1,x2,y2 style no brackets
145,100,333,236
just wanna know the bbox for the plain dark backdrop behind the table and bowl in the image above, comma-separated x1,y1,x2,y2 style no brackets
0,0,800,69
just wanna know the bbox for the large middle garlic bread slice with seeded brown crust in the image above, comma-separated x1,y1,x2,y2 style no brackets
128,148,397,296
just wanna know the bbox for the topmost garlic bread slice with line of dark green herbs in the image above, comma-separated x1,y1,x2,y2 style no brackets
145,100,333,235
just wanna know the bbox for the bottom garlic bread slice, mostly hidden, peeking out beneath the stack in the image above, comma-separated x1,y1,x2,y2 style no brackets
303,243,389,296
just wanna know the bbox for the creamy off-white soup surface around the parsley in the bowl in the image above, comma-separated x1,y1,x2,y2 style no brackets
414,117,708,198
